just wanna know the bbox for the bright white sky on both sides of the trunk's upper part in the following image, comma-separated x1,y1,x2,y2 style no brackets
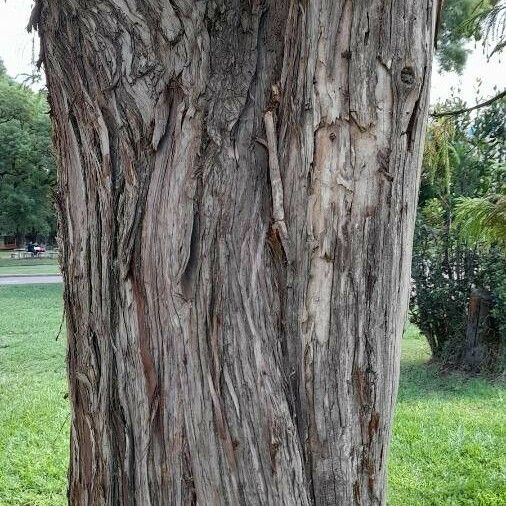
0,0,506,105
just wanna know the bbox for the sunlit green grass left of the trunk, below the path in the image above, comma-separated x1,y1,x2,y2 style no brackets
0,284,69,506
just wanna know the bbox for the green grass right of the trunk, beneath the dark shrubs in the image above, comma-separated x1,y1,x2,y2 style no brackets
389,326,506,506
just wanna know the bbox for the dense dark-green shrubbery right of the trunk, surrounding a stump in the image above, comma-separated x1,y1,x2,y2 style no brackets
411,101,506,366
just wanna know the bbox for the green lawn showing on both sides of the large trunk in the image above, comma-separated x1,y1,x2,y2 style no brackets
0,285,506,506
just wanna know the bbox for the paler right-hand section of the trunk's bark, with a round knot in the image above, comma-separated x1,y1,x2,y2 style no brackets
280,0,434,504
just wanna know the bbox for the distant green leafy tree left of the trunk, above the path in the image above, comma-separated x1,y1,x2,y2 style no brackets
0,59,55,241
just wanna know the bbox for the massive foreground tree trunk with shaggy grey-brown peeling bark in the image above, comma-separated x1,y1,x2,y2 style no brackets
33,0,436,506
